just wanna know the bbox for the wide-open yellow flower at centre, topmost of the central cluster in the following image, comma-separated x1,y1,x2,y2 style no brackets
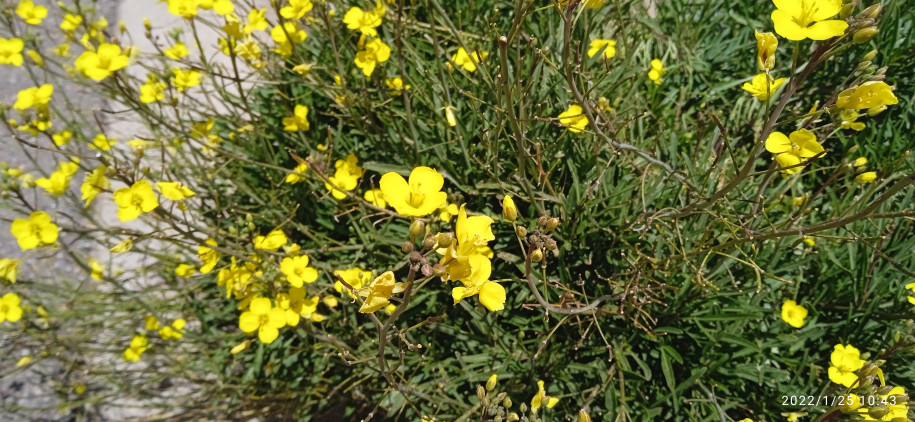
380,166,448,217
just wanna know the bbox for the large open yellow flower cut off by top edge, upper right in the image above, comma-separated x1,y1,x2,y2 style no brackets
772,0,848,41
